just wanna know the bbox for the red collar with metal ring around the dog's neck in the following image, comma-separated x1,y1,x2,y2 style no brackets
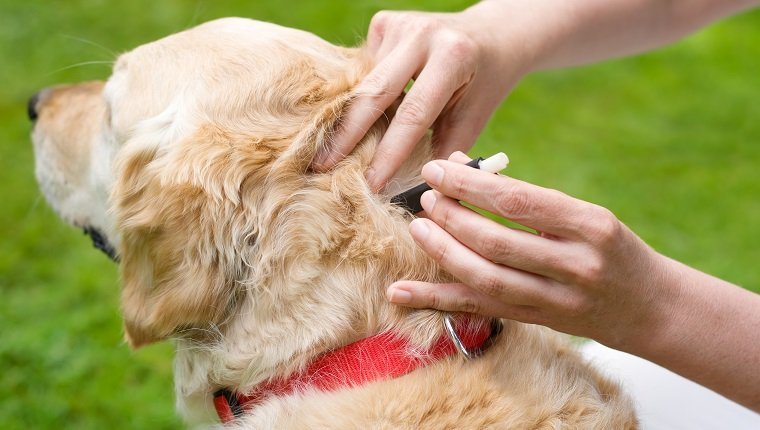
214,318,501,423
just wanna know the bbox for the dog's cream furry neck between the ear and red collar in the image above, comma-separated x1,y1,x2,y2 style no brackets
175,132,464,420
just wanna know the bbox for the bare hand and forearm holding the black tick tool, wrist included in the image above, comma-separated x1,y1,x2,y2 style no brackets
387,154,760,411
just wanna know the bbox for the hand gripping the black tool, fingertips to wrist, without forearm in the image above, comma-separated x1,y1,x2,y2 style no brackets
387,153,677,349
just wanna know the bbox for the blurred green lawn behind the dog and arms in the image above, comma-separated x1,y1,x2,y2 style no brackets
0,0,760,429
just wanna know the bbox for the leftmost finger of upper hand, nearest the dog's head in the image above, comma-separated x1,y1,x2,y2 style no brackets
312,44,422,171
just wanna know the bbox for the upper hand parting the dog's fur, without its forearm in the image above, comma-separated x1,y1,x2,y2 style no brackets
313,2,526,190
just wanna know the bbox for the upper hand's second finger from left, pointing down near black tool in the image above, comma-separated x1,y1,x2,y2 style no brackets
367,57,472,190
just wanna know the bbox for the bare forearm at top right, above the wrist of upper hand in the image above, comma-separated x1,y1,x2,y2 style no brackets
466,0,760,72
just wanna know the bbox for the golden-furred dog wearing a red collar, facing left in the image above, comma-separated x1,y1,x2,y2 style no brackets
29,18,637,429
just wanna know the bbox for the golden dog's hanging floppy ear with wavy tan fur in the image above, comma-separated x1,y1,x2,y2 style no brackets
112,129,285,347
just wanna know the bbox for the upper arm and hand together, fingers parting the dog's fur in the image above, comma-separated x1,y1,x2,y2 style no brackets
314,0,758,189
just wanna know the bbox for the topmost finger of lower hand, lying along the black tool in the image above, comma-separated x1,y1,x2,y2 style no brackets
422,160,597,238
